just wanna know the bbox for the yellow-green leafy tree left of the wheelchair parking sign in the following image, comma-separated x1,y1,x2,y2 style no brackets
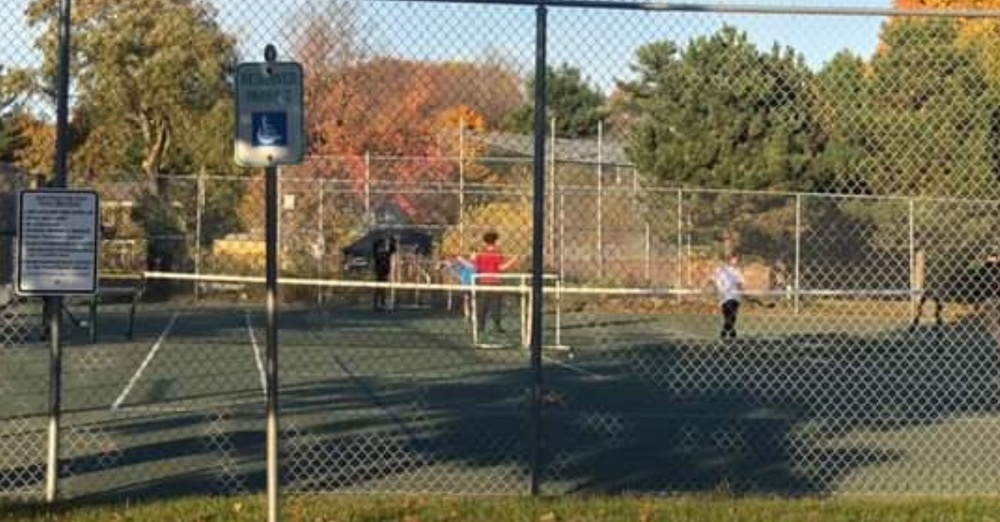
27,0,236,189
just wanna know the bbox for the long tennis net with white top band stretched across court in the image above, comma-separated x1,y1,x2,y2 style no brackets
139,272,928,350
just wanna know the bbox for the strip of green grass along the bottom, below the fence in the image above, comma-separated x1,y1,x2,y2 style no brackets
0,495,1000,522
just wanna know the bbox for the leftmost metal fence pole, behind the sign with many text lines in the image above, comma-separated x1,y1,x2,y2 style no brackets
45,0,73,503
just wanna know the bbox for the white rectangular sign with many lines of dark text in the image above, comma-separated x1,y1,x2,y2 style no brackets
14,190,101,295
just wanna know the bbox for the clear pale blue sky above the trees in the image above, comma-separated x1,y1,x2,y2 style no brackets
0,0,889,91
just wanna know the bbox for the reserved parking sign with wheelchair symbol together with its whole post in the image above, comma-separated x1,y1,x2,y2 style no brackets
234,45,305,522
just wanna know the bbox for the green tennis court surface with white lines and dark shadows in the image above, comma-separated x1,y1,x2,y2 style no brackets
0,294,1000,496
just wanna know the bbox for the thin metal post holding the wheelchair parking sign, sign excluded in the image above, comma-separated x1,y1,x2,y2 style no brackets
264,45,281,522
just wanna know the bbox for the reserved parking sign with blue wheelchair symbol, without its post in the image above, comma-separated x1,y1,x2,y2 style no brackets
234,62,305,167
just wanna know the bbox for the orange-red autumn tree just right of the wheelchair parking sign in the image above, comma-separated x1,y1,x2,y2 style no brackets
295,4,519,228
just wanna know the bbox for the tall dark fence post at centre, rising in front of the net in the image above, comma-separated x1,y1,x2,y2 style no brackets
530,4,555,496
